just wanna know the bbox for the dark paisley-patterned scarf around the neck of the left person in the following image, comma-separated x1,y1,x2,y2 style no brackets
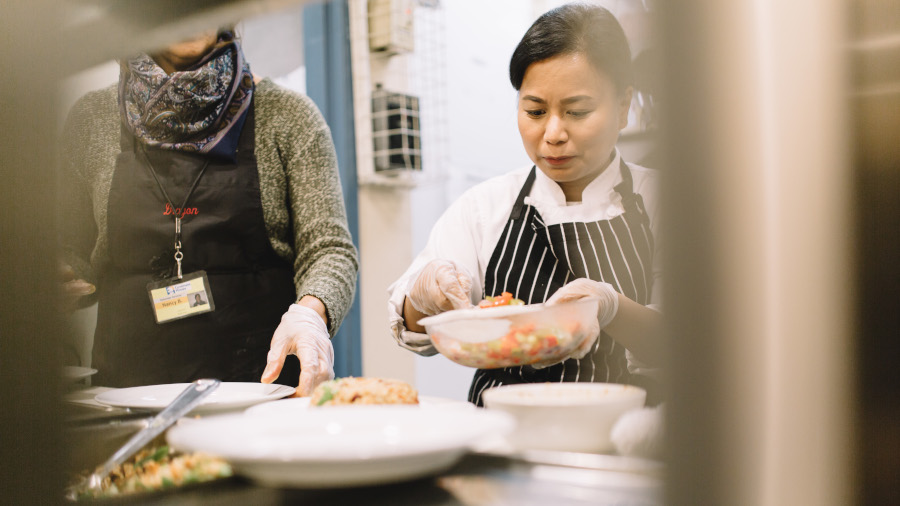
119,32,253,159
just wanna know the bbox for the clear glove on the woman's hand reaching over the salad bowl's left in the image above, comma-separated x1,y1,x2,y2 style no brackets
406,260,472,315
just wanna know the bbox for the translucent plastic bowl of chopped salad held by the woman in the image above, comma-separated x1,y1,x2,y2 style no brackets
419,298,599,369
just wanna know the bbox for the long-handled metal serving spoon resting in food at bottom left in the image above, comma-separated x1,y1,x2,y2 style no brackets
66,379,221,500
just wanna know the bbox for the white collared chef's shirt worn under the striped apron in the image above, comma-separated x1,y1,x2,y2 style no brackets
388,152,661,368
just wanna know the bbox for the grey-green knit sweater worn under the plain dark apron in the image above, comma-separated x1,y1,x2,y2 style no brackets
59,79,358,335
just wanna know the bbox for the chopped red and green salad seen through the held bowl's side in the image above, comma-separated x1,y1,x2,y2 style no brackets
431,322,584,369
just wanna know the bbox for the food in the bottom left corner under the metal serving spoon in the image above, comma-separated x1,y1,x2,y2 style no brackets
77,445,232,499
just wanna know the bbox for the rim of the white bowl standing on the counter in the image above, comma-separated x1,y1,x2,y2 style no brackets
481,381,647,407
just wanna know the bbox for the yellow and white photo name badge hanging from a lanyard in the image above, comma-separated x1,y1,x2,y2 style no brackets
147,271,216,323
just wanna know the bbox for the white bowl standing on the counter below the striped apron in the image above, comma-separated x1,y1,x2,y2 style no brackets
482,383,647,453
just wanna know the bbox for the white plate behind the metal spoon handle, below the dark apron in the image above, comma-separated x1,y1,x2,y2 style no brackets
94,382,295,414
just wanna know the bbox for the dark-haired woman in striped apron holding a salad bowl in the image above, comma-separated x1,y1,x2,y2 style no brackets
390,5,660,405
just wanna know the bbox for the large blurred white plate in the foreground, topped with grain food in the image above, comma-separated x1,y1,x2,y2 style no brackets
167,406,515,488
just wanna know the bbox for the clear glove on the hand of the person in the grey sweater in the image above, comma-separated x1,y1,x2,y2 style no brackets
261,304,334,396
